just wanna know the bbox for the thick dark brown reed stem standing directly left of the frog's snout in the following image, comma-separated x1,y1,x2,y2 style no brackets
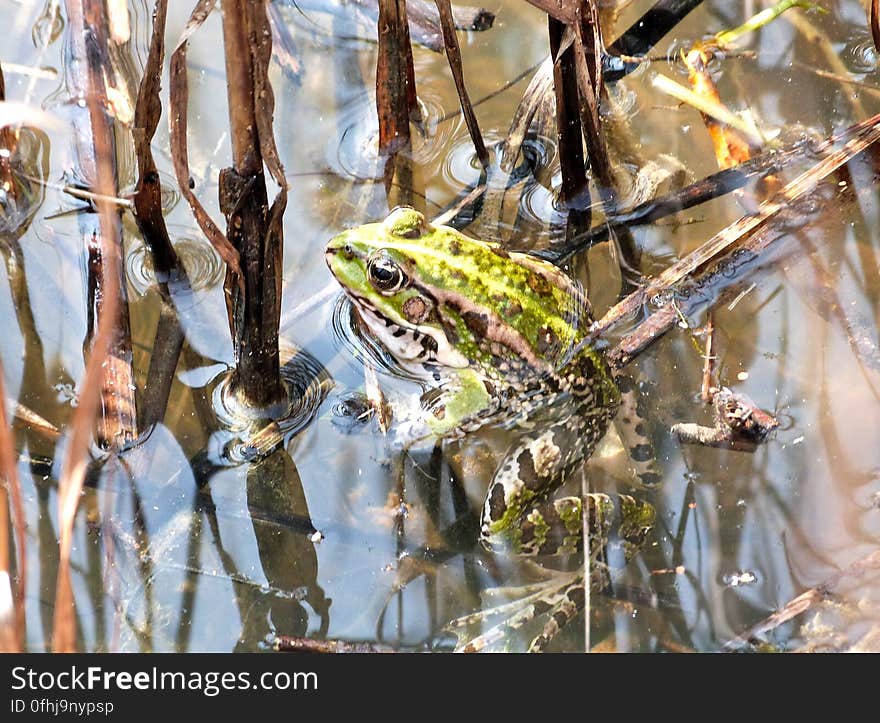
220,0,287,410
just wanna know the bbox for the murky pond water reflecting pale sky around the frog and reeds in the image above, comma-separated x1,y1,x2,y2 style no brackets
0,0,880,651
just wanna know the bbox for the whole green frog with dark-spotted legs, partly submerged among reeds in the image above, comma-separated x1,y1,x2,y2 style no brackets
326,208,654,650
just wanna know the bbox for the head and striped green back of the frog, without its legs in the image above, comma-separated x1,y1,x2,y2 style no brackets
326,208,589,377
